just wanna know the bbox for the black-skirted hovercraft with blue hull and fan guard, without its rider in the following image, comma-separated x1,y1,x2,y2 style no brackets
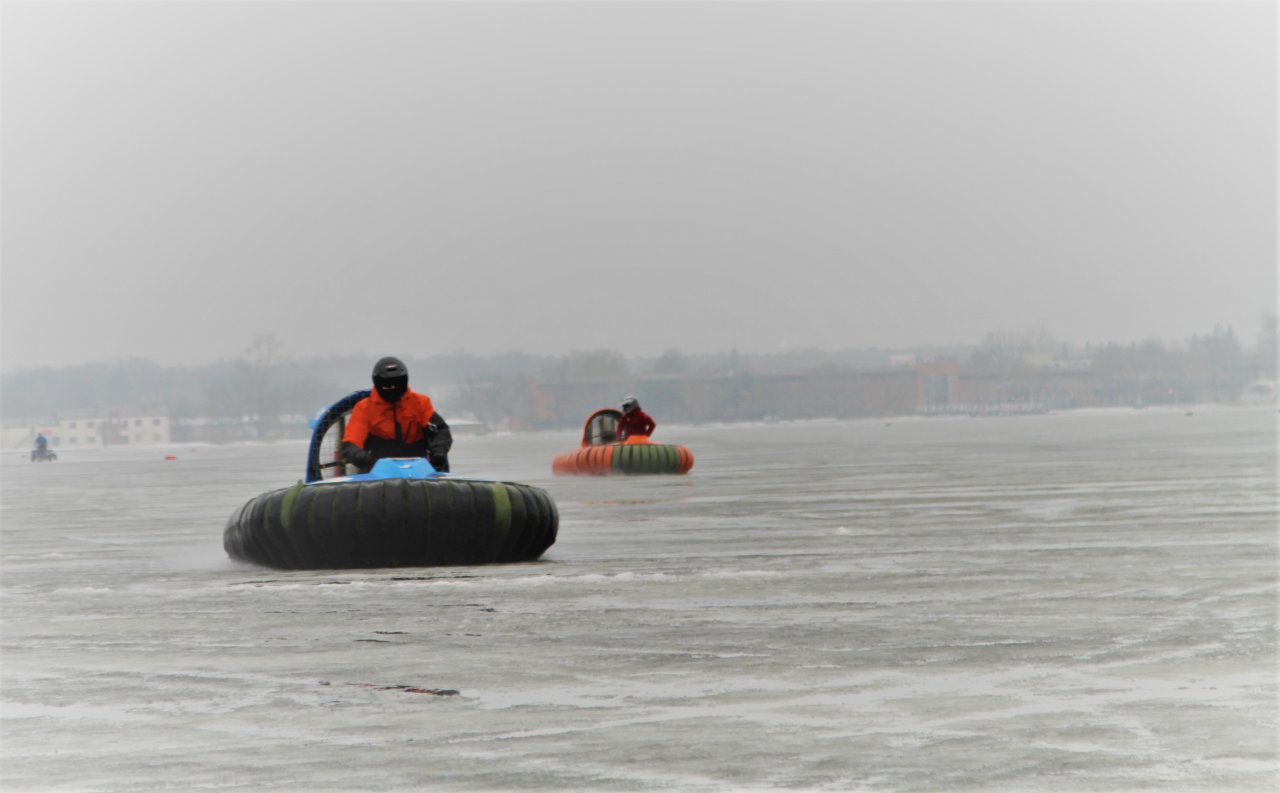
223,390,559,569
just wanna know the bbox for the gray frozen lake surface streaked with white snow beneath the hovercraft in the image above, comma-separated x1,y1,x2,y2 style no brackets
0,407,1280,793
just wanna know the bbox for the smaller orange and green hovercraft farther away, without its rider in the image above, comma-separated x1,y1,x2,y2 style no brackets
552,408,694,476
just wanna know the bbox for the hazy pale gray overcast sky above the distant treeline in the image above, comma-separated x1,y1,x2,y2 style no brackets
0,0,1277,370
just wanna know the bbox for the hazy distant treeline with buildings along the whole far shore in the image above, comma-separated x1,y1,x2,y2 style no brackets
0,315,1276,439
